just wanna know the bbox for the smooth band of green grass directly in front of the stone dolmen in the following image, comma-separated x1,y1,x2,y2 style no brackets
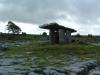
7,44,100,58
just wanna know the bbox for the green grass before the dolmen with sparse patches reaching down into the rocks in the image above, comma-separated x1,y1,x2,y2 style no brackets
5,43,100,67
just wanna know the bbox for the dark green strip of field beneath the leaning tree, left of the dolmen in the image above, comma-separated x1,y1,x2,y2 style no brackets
0,33,43,42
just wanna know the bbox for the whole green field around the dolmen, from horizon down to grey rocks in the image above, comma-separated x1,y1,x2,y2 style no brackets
0,35,100,67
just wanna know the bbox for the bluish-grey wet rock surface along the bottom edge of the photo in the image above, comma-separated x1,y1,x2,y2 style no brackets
0,57,97,75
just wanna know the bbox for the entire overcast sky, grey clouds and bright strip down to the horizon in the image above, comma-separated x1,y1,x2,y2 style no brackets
0,0,100,35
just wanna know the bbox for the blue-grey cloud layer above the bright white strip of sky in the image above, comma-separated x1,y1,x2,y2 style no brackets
0,0,100,25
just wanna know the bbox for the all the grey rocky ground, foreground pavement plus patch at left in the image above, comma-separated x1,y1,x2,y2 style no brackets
0,42,100,75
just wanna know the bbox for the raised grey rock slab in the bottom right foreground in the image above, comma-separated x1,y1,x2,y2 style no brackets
65,60,97,75
